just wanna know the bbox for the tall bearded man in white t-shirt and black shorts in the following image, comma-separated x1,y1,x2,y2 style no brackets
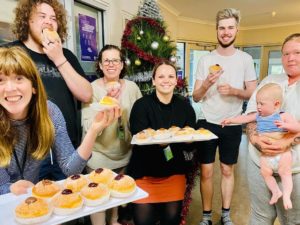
193,9,257,225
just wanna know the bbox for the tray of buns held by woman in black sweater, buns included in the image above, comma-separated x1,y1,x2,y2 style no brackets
131,126,218,145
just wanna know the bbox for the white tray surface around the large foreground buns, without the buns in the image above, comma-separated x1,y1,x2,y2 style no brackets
0,187,148,225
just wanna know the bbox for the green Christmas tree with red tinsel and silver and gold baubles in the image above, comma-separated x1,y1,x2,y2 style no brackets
122,0,176,94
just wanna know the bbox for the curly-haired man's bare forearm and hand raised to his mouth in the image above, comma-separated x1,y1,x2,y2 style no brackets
43,42,92,102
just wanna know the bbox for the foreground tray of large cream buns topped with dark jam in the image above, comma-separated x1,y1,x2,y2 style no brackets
0,168,148,225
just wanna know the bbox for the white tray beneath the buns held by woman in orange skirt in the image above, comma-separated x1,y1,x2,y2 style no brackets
131,132,218,145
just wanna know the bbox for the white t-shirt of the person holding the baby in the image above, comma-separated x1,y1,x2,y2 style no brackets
245,74,300,173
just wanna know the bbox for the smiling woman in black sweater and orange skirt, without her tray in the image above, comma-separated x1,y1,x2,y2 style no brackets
127,61,196,225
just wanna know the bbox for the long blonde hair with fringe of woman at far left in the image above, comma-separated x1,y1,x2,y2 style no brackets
0,47,54,167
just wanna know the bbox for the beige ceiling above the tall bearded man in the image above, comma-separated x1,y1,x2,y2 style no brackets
157,0,300,30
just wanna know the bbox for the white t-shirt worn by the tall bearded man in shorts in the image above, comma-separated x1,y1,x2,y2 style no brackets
196,49,256,124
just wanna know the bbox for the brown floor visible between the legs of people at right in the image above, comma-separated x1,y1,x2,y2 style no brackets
187,135,279,225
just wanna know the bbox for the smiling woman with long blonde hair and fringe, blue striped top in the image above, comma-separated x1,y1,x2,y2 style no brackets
0,47,120,195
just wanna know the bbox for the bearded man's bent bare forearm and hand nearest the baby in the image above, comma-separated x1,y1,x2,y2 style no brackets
218,80,257,100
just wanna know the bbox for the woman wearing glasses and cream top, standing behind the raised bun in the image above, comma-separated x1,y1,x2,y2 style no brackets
82,45,142,225
